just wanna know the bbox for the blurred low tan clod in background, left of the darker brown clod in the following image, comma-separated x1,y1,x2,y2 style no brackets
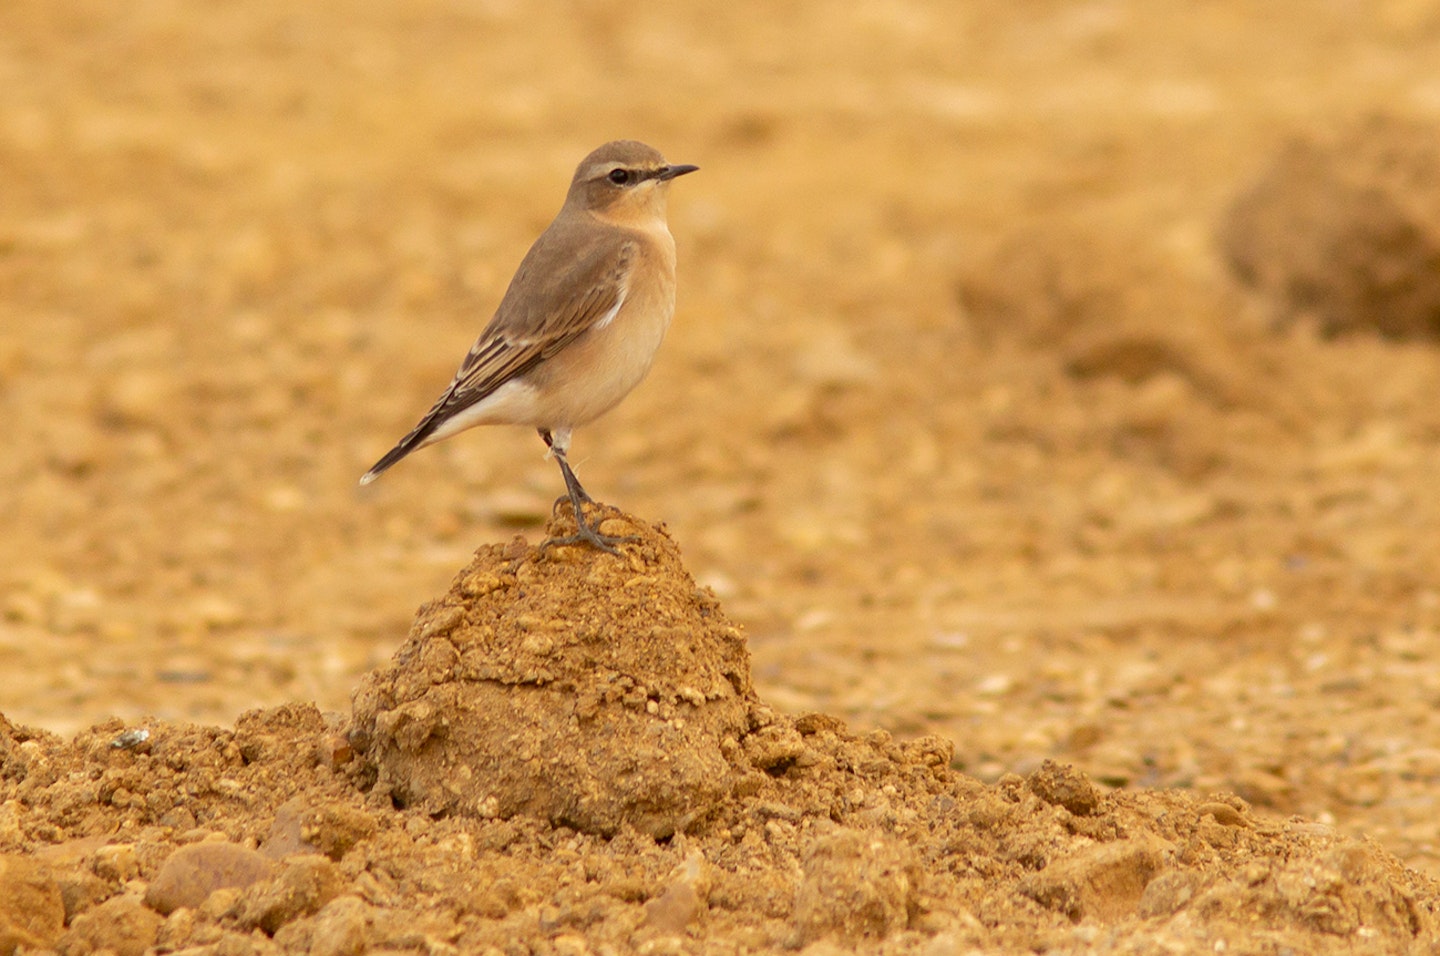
956,215,1273,479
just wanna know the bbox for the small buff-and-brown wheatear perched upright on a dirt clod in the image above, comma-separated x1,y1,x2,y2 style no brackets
360,140,698,554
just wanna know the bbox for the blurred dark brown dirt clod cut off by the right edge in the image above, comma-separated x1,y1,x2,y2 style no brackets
1221,117,1440,340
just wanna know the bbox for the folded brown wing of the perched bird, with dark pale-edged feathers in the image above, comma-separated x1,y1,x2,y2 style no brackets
360,222,636,484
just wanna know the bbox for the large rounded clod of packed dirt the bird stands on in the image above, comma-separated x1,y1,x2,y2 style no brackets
353,518,759,837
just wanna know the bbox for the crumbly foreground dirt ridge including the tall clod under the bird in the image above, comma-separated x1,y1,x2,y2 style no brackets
0,518,1440,955
